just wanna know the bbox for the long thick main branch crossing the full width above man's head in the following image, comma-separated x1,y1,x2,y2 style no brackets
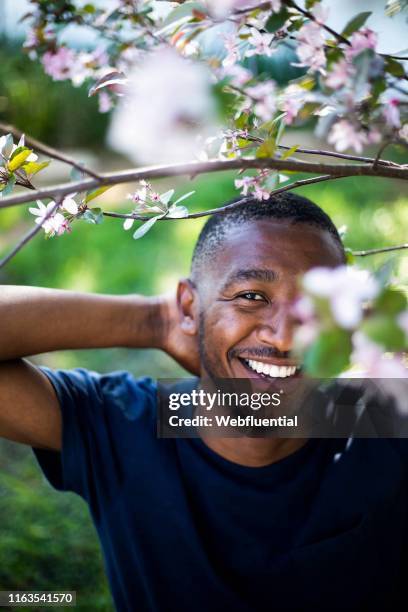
0,157,408,208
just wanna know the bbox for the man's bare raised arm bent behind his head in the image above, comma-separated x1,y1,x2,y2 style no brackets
0,286,196,450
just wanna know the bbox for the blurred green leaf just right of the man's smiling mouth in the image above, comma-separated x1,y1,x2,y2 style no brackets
304,328,352,378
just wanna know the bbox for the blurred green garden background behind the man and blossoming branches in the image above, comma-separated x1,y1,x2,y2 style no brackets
0,0,408,610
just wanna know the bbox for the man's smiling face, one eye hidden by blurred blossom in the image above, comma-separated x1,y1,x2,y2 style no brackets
199,220,343,382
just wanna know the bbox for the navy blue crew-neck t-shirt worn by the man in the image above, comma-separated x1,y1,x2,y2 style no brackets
33,368,408,612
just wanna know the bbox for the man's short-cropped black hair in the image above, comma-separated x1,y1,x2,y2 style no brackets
191,192,346,279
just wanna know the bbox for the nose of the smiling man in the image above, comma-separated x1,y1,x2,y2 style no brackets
257,303,295,353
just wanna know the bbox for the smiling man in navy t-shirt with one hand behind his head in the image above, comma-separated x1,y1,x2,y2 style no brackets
0,194,408,612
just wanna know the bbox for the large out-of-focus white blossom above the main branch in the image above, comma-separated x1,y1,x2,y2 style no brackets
108,49,219,163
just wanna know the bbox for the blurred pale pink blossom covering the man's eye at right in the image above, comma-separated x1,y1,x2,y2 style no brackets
302,266,379,329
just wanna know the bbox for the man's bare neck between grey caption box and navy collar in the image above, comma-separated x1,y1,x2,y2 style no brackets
201,434,307,467
